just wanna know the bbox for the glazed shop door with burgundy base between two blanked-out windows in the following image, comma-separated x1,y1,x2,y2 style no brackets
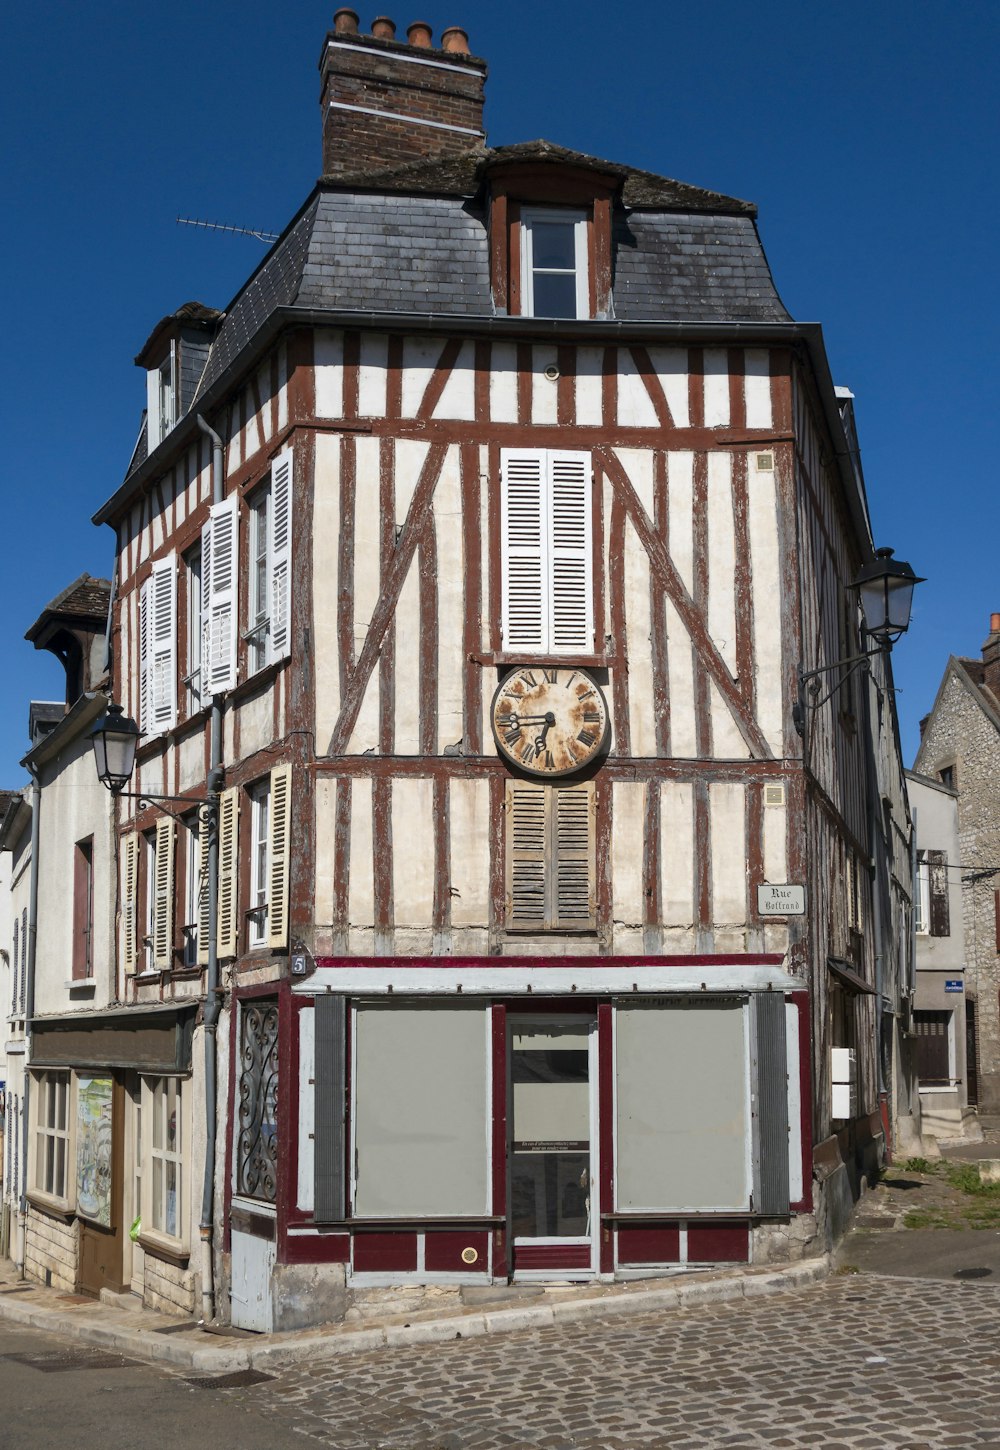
507,1016,599,1279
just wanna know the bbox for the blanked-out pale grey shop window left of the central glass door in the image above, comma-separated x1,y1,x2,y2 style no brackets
352,1003,490,1218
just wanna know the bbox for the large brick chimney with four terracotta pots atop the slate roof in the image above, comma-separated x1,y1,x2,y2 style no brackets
319,9,486,177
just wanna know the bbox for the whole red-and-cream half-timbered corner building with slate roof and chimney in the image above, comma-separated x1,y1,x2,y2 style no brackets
19,10,906,1328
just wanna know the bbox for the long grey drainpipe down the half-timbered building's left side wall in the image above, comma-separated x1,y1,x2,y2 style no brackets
197,413,223,1324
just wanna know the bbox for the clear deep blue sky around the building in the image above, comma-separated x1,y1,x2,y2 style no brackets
0,0,1000,787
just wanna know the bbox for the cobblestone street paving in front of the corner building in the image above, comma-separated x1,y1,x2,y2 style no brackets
205,1275,1000,1450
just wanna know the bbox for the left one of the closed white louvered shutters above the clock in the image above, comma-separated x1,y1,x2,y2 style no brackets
500,448,548,650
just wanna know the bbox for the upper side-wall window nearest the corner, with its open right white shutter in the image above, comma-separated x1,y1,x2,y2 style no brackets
243,448,291,674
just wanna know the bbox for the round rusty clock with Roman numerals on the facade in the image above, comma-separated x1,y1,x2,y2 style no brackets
490,666,607,779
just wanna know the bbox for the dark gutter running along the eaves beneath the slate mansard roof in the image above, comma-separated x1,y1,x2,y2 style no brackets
91,314,872,561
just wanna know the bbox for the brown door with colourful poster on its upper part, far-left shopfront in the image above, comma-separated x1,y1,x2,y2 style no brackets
75,1077,125,1295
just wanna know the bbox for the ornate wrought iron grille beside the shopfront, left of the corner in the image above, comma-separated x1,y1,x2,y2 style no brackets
236,1002,278,1204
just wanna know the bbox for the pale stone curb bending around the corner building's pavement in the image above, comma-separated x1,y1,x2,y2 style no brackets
0,1254,832,1375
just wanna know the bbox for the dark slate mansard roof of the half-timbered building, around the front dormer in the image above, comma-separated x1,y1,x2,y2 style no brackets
126,141,791,490
